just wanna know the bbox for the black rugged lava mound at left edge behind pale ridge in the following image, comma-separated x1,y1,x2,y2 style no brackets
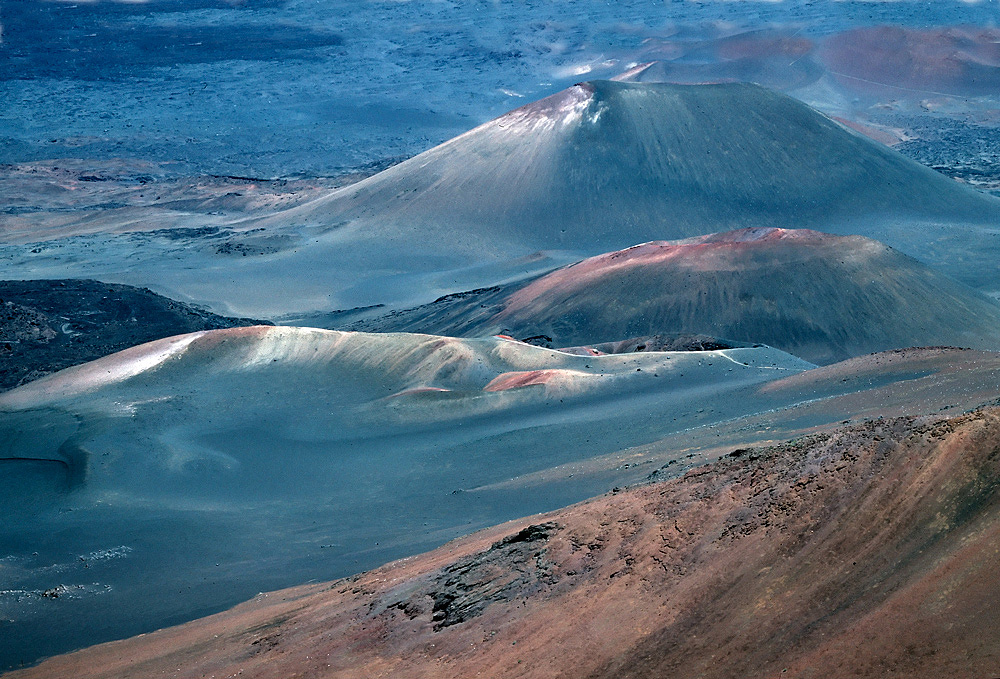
0,279,262,391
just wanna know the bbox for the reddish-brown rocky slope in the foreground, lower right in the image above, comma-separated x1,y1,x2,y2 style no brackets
17,409,1000,679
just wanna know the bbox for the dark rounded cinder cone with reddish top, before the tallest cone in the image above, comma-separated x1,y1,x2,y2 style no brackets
354,228,1000,363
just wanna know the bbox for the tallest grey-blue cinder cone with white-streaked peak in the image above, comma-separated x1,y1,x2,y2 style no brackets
280,81,1000,294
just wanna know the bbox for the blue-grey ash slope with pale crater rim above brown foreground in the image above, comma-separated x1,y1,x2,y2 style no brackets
9,327,1000,667
